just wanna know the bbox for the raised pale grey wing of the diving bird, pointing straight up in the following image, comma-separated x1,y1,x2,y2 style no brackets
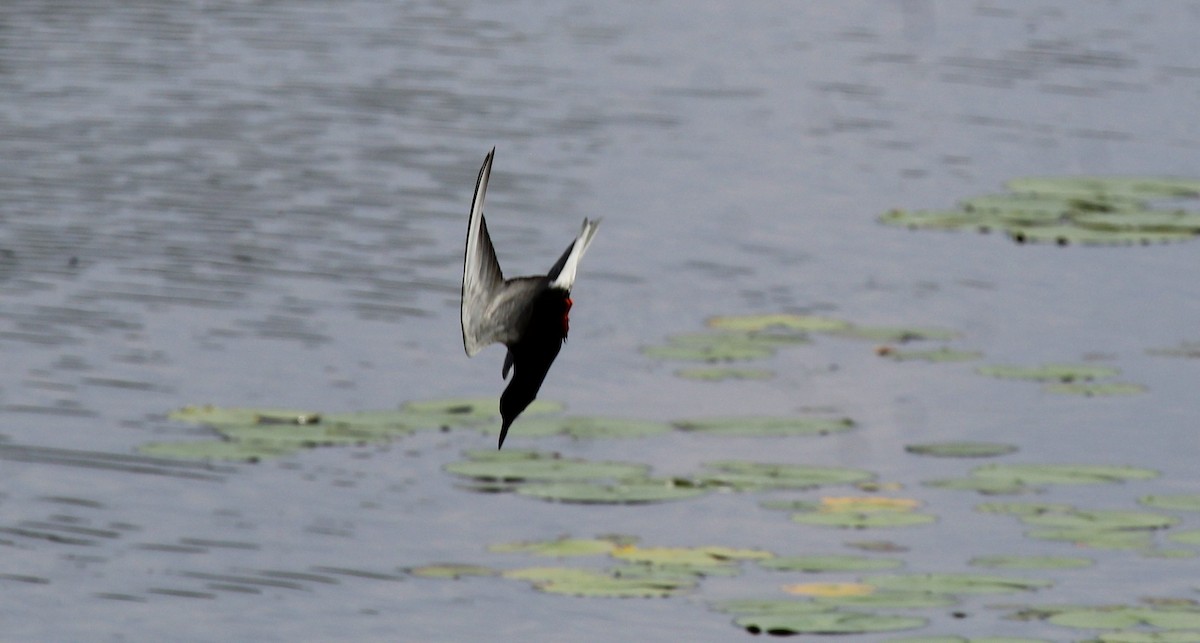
461,148,504,356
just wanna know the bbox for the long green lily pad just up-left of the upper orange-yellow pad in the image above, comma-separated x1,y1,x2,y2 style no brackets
697,461,875,491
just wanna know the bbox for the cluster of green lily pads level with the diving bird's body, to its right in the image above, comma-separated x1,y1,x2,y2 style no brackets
642,313,964,381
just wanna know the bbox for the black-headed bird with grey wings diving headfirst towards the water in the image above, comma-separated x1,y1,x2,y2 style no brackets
461,148,600,449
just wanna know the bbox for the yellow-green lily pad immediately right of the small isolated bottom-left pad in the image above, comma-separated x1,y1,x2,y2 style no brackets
504,567,696,599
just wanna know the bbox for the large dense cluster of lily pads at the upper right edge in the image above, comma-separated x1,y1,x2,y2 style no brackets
880,176,1200,246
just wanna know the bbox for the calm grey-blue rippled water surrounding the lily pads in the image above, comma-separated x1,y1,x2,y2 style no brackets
0,0,1200,641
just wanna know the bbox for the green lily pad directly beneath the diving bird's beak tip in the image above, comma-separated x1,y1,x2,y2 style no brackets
444,453,649,482
